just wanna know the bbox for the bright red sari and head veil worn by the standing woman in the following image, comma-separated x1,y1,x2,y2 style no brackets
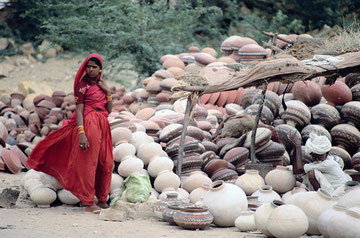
27,54,113,205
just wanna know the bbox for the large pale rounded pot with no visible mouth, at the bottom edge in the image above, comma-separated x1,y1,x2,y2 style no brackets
266,204,309,238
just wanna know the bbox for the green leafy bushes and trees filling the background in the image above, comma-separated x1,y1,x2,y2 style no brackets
0,0,360,87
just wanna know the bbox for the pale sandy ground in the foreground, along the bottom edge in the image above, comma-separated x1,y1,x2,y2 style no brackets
0,172,264,238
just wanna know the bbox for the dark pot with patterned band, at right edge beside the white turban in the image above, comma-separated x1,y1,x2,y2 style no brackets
330,124,360,154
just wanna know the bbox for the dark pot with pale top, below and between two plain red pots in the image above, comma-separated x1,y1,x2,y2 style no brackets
311,104,341,130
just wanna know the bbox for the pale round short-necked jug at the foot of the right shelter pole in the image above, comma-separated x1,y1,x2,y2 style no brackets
265,166,296,193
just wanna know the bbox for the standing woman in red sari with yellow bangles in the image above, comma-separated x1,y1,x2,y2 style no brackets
27,54,113,213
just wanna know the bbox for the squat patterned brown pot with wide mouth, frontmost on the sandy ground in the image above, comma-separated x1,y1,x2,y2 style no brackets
173,206,214,230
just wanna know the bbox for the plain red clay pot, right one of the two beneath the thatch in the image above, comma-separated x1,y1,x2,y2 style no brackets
321,80,352,107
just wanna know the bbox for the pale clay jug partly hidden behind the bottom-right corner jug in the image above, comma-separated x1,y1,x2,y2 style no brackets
317,205,347,238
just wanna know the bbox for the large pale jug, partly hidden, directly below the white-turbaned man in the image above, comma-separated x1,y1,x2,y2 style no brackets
287,189,337,235
